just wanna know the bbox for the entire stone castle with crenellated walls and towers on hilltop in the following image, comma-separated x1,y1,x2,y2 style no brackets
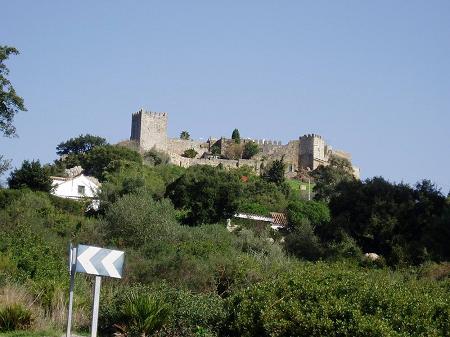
130,109,359,178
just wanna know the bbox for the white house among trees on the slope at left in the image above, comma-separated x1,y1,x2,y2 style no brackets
51,166,101,208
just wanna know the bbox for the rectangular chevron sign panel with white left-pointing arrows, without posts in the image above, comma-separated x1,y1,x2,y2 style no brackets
75,245,124,278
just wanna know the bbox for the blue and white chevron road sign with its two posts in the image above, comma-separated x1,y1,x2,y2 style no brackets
66,245,125,337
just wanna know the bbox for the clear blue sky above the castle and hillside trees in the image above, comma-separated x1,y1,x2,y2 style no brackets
0,0,450,194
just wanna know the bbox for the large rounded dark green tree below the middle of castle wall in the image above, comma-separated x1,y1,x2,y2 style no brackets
166,165,242,225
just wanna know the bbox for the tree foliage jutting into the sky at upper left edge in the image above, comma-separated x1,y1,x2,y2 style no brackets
0,46,27,137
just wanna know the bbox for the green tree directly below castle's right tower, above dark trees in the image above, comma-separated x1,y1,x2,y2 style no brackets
311,156,355,201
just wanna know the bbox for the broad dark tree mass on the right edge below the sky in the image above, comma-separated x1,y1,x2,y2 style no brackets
324,177,450,264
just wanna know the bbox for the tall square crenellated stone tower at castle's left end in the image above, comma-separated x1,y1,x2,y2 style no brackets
130,109,167,152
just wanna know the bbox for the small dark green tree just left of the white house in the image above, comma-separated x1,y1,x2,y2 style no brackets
8,160,52,192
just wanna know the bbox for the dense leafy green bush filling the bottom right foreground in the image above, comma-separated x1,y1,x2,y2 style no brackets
221,263,450,337
